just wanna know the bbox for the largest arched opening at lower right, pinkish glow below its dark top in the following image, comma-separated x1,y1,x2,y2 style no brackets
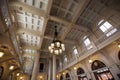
92,60,115,80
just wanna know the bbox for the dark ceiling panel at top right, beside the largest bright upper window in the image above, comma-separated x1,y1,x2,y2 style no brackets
76,0,108,28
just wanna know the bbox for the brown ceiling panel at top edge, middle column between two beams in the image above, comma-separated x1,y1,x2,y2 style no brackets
50,0,81,21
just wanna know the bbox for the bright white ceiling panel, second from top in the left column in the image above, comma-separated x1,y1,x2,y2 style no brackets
16,12,44,32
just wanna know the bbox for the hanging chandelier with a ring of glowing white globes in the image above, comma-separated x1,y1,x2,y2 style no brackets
48,26,65,55
